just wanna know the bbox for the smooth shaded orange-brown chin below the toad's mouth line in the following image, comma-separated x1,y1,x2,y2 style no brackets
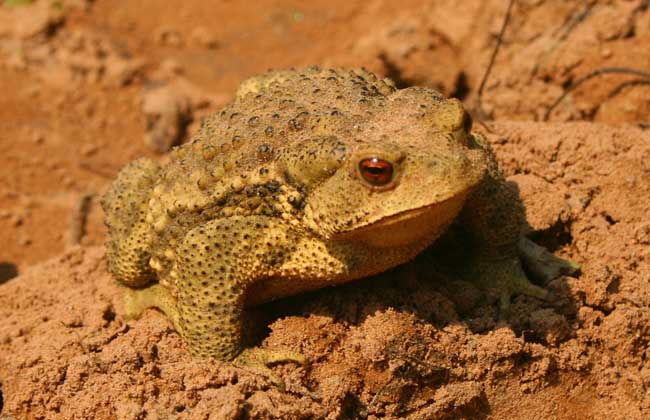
333,193,467,248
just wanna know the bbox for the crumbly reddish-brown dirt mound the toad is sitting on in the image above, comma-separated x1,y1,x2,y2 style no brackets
0,123,650,419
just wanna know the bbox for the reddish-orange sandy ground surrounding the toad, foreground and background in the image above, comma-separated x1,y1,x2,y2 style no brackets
0,0,650,420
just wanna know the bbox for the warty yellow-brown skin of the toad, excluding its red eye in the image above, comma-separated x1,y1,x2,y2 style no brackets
103,68,543,360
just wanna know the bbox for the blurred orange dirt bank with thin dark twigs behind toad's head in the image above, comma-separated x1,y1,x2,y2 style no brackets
344,0,650,124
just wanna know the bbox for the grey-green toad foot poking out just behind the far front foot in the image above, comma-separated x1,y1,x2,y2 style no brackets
519,236,580,284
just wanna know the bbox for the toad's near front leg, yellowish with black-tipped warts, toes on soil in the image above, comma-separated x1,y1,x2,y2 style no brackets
177,216,304,374
